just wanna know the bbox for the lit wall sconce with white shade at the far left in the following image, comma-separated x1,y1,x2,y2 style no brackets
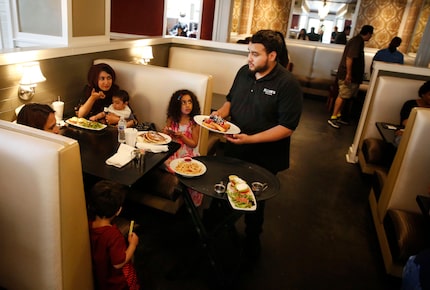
18,61,46,101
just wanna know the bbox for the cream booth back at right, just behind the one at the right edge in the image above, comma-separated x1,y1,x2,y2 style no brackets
358,76,424,174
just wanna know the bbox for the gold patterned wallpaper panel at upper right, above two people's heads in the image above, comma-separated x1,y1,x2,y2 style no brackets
354,0,407,48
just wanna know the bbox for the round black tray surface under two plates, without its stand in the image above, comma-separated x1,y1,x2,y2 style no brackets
178,156,280,201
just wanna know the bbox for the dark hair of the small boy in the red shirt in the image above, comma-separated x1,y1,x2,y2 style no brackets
89,180,127,218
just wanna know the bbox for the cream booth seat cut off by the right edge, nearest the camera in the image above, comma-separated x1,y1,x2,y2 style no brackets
369,108,430,276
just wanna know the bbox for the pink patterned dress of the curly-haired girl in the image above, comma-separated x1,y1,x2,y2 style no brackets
166,121,203,206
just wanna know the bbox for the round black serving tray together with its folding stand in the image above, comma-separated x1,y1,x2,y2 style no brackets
173,156,280,286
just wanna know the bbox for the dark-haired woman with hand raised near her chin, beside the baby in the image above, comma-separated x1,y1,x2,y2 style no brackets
76,63,119,119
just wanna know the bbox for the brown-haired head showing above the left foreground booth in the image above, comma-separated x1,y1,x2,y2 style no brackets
16,103,60,134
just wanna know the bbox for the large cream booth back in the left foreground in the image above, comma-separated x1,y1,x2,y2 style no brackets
0,120,93,290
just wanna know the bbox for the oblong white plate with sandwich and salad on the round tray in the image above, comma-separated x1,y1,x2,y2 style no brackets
226,175,257,211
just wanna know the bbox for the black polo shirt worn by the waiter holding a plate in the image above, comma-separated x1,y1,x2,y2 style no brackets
226,64,303,173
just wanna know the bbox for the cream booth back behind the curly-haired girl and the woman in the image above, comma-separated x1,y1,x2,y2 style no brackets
94,59,212,155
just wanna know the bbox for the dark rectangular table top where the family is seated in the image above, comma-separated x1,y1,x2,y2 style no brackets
60,126,180,186
